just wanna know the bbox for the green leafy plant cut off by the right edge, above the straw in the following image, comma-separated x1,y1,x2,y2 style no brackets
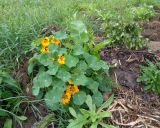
138,60,160,94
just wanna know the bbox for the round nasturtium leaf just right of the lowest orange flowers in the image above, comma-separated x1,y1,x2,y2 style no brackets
73,91,87,105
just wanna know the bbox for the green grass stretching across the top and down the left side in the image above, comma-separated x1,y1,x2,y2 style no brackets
0,0,160,69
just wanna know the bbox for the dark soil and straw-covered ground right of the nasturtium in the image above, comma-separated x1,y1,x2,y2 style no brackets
100,48,160,128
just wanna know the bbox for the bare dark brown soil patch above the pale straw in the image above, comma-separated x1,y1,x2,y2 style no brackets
100,48,156,91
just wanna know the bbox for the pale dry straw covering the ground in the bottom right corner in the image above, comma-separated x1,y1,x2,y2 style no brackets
108,88,160,128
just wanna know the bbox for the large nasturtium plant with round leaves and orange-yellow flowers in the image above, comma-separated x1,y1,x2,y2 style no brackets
28,21,110,110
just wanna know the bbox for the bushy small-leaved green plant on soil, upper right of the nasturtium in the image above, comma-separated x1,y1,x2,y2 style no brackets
105,18,144,49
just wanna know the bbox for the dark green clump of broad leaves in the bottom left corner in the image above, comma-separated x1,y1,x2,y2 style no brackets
0,70,27,128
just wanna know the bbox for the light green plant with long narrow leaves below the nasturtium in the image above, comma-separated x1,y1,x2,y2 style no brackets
67,95,114,128
